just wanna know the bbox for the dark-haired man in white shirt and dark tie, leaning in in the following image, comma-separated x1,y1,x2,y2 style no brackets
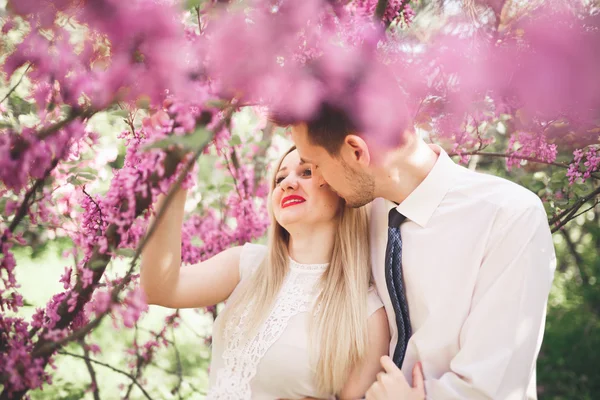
284,106,555,400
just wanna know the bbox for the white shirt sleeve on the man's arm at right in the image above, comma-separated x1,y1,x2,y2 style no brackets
425,204,556,400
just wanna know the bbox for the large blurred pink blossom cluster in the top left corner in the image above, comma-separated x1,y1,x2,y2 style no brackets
4,0,198,108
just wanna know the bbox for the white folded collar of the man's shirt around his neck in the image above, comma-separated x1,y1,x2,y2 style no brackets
386,144,457,228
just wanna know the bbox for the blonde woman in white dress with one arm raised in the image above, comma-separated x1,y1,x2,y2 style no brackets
141,148,389,400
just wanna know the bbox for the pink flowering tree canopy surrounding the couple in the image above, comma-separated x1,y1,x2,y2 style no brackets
0,0,600,399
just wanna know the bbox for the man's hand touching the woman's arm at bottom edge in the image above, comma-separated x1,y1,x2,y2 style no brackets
366,356,425,400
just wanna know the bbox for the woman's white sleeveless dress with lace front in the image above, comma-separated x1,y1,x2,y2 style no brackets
207,243,383,400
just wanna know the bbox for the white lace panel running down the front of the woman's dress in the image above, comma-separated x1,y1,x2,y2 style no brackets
207,260,327,400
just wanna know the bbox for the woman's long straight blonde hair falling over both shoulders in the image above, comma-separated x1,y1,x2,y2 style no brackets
219,147,371,394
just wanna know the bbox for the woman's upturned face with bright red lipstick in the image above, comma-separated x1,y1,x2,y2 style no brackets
271,150,342,230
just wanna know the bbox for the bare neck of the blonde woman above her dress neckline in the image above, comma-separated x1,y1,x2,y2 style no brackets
288,223,336,264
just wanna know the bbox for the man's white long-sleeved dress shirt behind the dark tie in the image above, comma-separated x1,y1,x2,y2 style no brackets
370,146,556,400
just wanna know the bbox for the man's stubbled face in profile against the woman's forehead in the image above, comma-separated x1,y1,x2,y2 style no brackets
291,124,375,207
